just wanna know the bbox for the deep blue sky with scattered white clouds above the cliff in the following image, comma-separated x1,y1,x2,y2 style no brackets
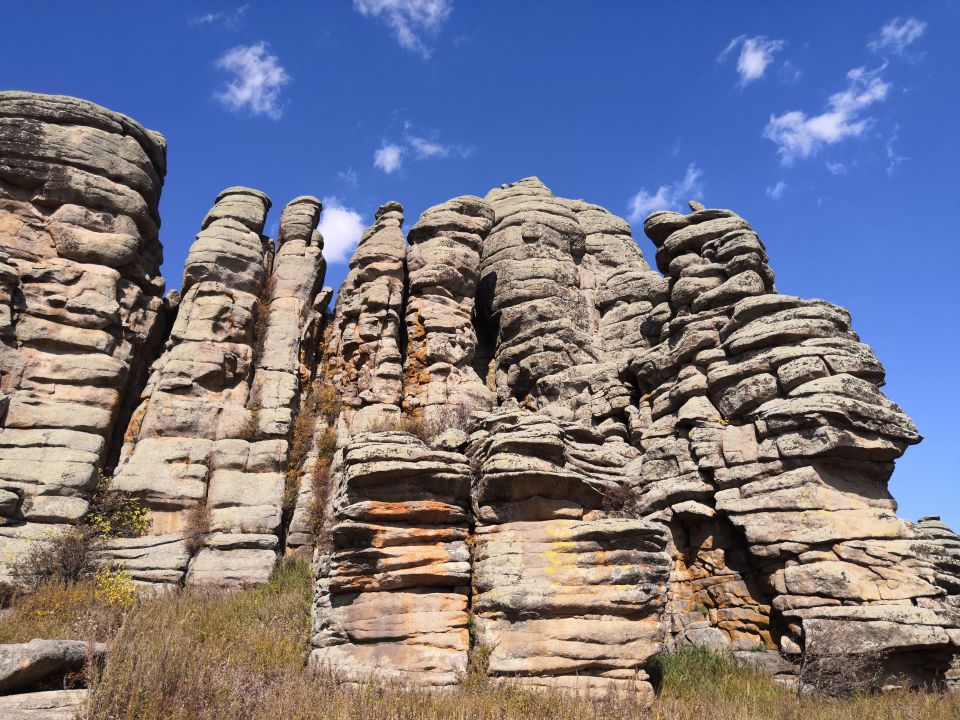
0,0,960,530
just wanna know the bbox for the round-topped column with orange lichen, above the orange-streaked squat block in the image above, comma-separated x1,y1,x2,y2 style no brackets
404,196,494,422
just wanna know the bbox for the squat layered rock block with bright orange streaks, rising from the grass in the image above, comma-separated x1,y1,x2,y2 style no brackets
311,432,470,687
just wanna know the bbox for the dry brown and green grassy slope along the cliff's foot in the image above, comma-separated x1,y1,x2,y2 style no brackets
0,561,960,720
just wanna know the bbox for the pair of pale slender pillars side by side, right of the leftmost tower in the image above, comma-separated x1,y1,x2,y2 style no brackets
112,188,329,586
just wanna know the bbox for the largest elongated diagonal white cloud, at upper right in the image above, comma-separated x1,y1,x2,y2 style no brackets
763,66,890,165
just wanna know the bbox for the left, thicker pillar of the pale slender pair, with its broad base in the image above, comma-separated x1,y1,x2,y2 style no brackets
114,187,274,584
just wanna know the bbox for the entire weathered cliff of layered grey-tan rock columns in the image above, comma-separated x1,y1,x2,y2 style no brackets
0,93,960,692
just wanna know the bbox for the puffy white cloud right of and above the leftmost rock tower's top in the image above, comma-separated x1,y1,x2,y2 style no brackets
215,41,290,120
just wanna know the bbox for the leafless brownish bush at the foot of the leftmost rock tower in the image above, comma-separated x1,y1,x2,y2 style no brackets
11,525,102,588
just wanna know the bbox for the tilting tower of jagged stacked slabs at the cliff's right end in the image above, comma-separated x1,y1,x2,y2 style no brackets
631,204,960,677
